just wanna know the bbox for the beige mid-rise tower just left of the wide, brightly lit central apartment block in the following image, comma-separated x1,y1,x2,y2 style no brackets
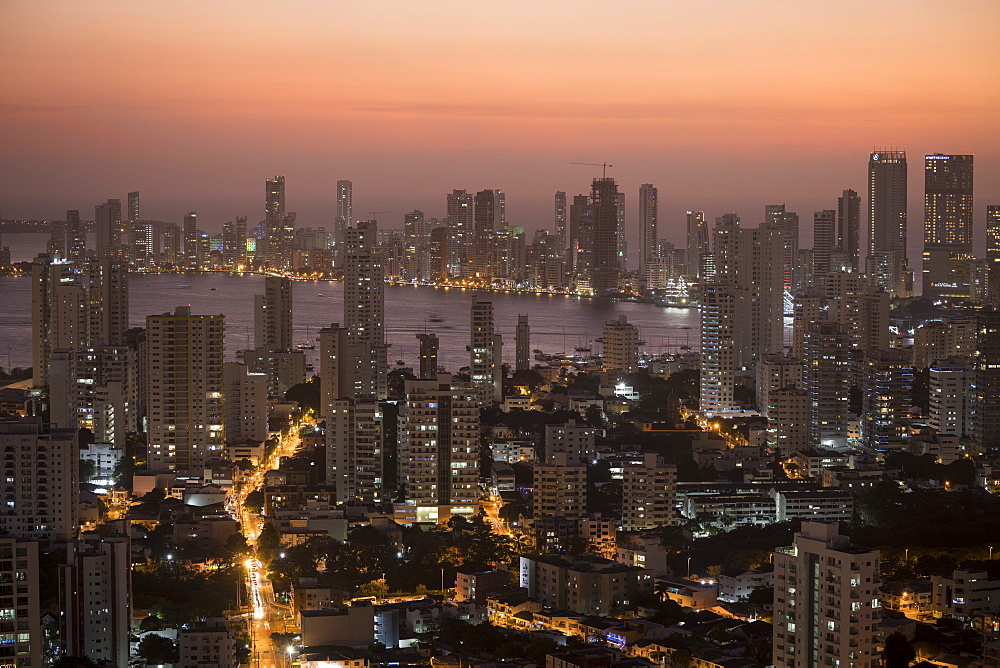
326,399,388,503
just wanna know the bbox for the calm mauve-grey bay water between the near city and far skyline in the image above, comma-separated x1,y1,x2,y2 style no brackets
0,234,698,372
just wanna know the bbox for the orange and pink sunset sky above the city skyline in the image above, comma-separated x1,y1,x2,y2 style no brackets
0,0,1000,247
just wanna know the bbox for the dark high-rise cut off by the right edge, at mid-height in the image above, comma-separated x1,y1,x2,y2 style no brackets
971,311,1000,448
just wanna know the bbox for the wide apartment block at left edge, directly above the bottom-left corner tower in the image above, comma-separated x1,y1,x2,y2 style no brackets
0,418,80,544
